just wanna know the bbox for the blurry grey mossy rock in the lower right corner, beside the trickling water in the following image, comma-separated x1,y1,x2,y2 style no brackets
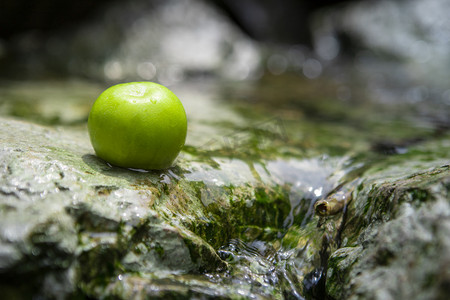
327,159,450,299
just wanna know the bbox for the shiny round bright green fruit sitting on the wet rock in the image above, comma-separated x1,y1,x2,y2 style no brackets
88,82,187,170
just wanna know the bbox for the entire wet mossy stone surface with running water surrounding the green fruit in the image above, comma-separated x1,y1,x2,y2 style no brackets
0,76,450,299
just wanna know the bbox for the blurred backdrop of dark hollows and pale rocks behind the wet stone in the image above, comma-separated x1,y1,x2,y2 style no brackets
0,0,450,126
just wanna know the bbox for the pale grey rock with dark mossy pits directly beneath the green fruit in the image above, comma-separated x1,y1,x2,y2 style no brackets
0,119,223,296
